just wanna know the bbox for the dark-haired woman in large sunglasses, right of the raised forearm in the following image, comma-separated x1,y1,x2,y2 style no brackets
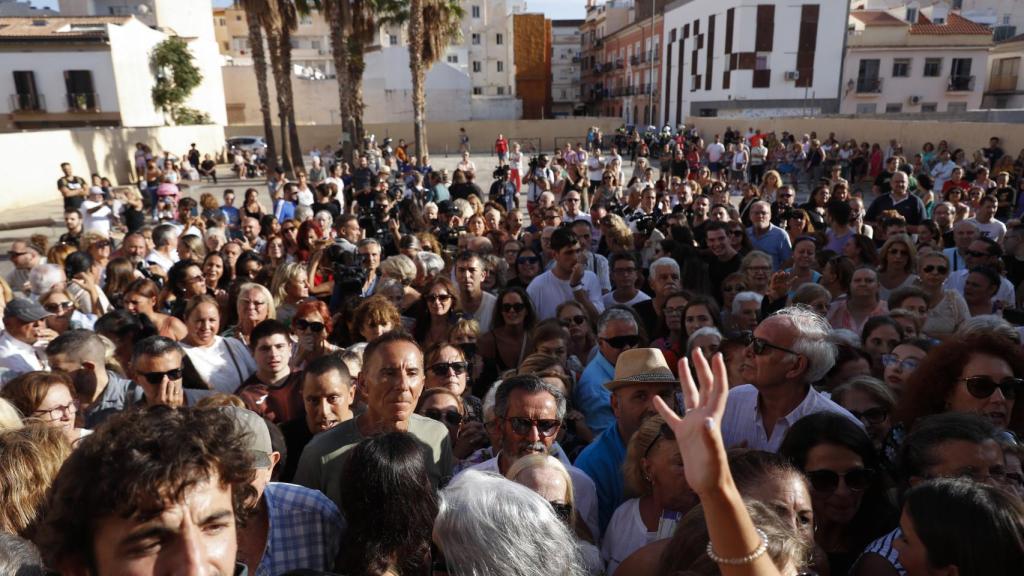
779,412,897,574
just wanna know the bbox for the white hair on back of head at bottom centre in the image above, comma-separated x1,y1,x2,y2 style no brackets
434,469,587,576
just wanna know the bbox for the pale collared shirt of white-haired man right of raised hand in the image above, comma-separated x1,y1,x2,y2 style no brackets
722,384,864,452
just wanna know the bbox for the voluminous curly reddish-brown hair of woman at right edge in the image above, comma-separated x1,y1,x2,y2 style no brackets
895,333,1024,434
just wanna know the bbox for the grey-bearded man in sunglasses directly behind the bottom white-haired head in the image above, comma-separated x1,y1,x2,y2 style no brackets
469,374,599,539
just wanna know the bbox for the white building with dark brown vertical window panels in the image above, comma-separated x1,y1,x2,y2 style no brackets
659,0,847,120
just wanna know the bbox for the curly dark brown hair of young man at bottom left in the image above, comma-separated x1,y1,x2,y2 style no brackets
37,406,258,566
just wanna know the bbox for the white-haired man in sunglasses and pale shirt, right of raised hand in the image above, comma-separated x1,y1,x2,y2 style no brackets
722,306,864,452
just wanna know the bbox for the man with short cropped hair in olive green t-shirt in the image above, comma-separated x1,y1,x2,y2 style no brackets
295,332,454,506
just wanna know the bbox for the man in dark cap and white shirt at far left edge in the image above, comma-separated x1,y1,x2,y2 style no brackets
0,298,53,377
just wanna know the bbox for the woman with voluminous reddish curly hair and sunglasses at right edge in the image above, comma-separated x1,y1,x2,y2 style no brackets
894,333,1024,435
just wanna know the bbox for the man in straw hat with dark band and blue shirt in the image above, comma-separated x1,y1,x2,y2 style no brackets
575,348,684,530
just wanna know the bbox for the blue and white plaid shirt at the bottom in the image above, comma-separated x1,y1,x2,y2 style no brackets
255,482,345,576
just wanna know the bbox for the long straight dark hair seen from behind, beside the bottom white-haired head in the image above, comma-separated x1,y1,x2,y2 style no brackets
338,433,437,576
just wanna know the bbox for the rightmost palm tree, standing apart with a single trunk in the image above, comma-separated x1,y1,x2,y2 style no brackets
409,0,463,158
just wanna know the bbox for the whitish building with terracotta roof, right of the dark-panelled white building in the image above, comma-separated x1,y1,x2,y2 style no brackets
841,7,992,114
